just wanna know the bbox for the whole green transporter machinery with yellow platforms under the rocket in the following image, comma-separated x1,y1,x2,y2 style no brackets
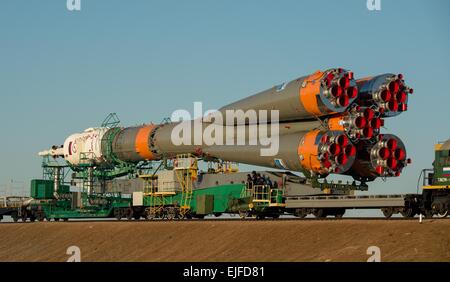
22,142,284,221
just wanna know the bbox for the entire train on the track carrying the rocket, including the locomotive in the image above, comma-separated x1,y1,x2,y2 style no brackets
0,140,450,222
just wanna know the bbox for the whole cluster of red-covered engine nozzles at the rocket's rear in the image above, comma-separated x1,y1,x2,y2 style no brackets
319,69,413,181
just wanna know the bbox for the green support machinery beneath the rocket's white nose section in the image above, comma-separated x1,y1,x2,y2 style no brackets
22,114,137,221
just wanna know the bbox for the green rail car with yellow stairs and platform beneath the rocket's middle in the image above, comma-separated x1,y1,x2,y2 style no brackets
140,155,284,219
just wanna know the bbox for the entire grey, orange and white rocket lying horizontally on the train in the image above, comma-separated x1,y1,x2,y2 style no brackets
39,68,413,182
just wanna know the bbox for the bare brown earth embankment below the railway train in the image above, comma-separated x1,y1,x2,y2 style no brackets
0,219,450,262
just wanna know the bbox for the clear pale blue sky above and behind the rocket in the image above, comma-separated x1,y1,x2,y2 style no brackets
0,0,450,200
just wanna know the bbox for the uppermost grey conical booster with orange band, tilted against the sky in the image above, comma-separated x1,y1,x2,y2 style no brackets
219,68,358,121
